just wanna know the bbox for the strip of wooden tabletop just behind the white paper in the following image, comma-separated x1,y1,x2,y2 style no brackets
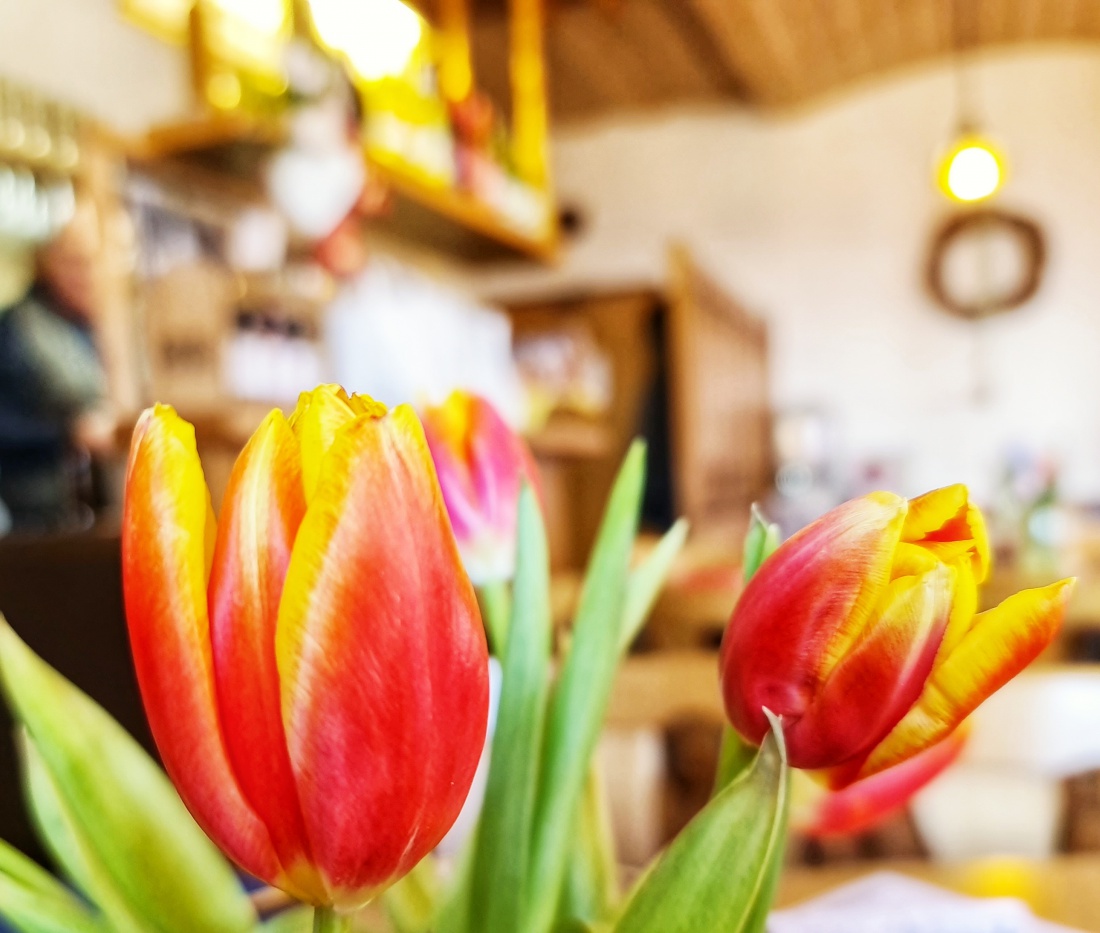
776,853,1100,933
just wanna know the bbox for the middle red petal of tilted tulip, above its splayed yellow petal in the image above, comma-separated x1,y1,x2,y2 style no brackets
785,564,955,769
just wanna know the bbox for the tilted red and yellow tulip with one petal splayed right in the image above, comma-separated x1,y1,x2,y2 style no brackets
721,485,1073,788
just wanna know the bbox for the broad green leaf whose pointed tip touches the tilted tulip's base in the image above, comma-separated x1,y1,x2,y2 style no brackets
614,714,790,933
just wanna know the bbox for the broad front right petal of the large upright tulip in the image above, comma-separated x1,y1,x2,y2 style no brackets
276,406,488,907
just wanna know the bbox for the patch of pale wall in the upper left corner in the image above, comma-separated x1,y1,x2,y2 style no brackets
0,0,191,133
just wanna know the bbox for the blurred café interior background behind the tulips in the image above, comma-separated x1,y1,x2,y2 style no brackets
0,0,1100,930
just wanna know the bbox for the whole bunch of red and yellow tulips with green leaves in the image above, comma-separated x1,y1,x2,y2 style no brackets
0,386,1070,933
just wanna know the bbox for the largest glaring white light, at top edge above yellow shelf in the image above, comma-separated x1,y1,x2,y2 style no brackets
309,0,424,81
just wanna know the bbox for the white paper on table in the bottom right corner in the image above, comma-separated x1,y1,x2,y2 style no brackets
768,871,1074,933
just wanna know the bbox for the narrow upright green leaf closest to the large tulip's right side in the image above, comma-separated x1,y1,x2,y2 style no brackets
470,487,551,933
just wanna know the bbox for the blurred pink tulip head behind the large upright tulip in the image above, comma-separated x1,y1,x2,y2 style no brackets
424,391,538,585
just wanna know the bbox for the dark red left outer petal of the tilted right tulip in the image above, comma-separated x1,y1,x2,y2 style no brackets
722,493,905,748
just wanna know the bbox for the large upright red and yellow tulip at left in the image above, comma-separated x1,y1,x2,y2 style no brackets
122,386,488,908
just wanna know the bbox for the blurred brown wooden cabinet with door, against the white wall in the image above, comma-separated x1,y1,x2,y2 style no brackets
508,249,772,569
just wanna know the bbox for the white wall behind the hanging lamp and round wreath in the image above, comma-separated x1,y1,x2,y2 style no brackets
483,46,1100,501
